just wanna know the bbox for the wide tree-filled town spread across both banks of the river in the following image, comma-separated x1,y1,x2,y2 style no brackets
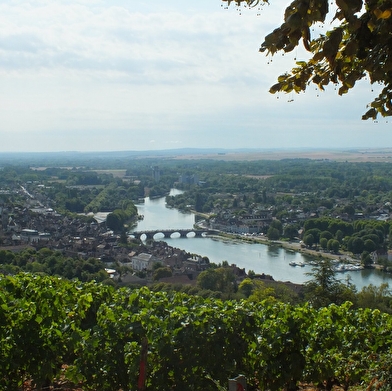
0,153,392,294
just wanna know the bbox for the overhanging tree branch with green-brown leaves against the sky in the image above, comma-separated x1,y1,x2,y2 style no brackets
223,0,392,119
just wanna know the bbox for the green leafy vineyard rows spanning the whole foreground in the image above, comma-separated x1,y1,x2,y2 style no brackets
0,274,392,391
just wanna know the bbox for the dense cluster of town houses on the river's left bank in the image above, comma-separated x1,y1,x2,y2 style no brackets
0,185,245,284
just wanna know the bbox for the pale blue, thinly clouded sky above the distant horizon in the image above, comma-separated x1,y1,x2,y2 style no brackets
0,0,392,152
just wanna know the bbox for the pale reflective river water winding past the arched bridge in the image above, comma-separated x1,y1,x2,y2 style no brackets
134,189,392,290
